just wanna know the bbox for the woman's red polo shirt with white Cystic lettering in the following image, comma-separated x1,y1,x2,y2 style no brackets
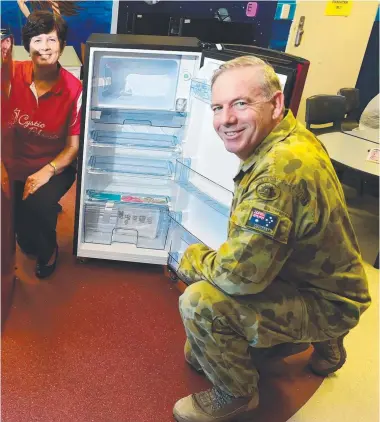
6,61,82,180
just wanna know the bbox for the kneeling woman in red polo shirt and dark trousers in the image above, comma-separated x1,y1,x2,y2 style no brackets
4,11,82,278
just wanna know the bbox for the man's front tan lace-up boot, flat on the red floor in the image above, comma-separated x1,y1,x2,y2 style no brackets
173,387,259,422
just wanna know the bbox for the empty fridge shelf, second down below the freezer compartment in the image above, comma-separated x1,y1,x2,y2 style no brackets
91,130,179,150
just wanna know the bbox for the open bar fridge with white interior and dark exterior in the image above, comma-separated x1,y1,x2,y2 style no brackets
74,34,309,280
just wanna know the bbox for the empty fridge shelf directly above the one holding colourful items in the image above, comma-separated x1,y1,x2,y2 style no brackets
88,155,174,178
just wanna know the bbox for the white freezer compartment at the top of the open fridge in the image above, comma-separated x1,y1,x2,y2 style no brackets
92,49,200,112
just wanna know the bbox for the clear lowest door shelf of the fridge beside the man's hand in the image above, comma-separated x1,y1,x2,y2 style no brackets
168,217,203,281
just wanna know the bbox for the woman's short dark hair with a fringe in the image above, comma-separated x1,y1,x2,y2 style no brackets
22,10,67,53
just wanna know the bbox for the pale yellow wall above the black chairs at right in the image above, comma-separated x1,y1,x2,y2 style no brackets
286,1,378,121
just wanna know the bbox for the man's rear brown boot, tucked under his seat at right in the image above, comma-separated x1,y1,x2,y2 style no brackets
310,333,347,377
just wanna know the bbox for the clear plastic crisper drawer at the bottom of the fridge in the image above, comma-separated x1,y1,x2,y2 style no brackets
84,201,170,250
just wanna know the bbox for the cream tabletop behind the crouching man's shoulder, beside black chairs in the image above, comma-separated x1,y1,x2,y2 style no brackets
317,131,379,178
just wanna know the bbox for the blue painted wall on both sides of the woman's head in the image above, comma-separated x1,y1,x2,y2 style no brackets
1,0,112,57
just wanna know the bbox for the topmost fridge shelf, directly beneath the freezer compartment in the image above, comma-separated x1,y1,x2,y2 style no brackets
91,107,187,128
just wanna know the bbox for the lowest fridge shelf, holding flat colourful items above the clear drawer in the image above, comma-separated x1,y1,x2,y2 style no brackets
86,189,170,207
